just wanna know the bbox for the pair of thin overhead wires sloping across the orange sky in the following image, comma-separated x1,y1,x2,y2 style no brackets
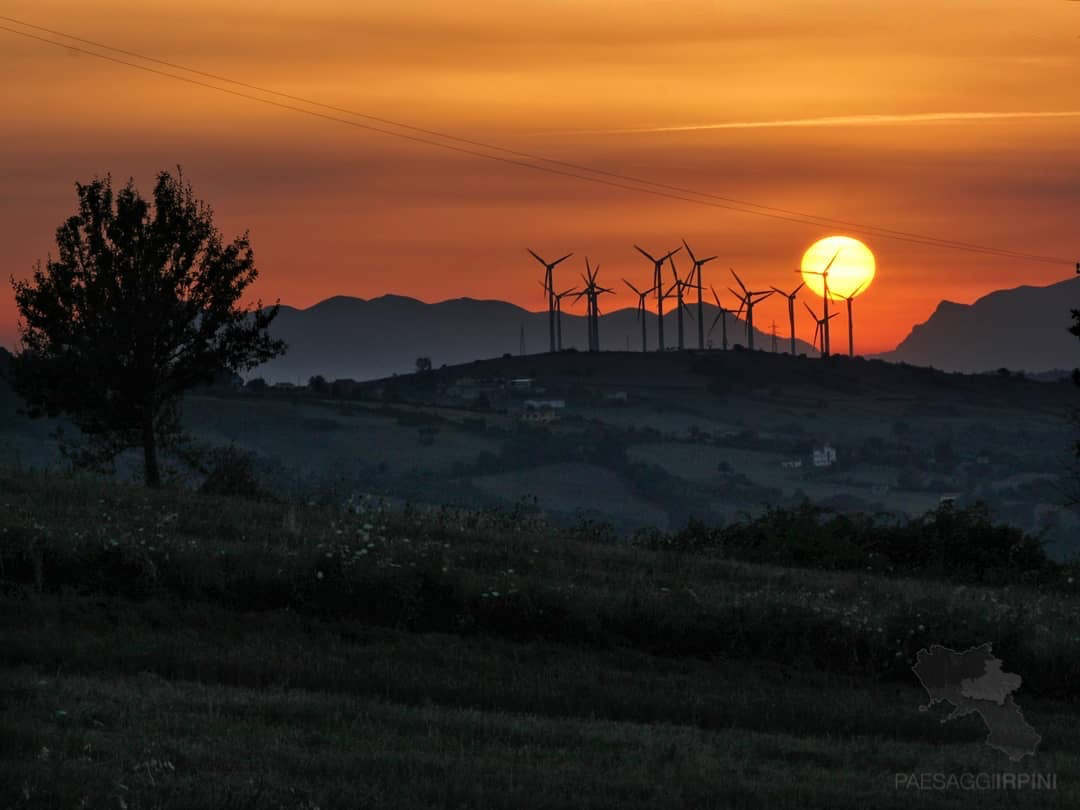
0,15,1074,265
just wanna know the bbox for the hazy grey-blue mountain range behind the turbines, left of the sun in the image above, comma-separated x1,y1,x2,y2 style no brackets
247,295,814,382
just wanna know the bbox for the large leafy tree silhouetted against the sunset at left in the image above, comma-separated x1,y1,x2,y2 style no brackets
12,170,285,486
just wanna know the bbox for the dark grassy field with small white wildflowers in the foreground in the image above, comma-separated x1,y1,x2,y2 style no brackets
0,473,1080,810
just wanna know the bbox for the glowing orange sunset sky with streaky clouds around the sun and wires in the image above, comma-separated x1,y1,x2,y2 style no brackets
0,0,1080,352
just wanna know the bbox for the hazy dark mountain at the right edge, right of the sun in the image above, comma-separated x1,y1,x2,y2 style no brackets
878,276,1080,373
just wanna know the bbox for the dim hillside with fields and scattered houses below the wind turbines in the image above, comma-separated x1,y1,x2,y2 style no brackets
0,350,1080,558
